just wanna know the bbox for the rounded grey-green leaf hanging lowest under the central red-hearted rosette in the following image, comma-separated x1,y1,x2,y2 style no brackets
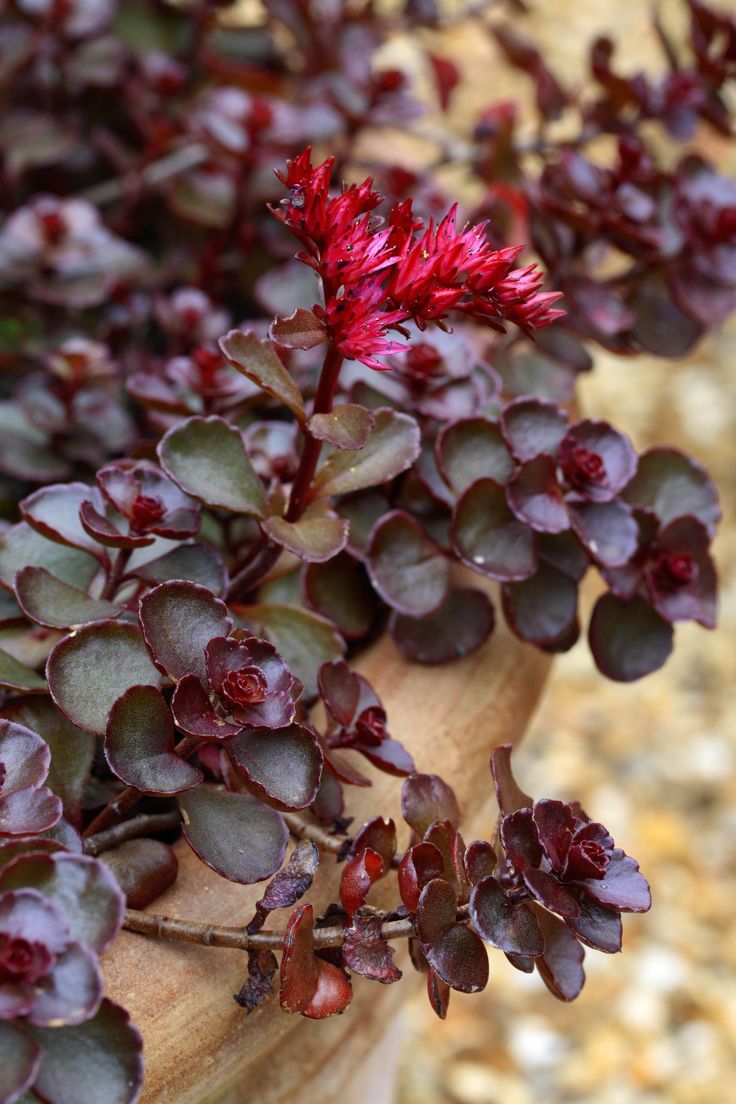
179,786,289,885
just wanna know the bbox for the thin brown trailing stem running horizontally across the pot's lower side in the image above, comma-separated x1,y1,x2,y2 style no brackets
122,905,468,951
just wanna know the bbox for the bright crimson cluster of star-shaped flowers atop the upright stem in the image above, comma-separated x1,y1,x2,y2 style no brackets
274,148,564,370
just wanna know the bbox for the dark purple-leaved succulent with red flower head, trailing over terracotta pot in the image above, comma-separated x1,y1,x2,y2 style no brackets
0,0,723,1104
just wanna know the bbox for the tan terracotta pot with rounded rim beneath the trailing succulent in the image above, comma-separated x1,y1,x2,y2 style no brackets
104,591,548,1104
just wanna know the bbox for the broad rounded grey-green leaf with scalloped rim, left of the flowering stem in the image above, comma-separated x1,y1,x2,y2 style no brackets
158,417,266,518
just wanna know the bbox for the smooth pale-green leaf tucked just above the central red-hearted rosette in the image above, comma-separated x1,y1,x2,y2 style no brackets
238,605,345,698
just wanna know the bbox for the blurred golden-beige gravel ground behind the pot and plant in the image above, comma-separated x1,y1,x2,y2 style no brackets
398,0,736,1104
